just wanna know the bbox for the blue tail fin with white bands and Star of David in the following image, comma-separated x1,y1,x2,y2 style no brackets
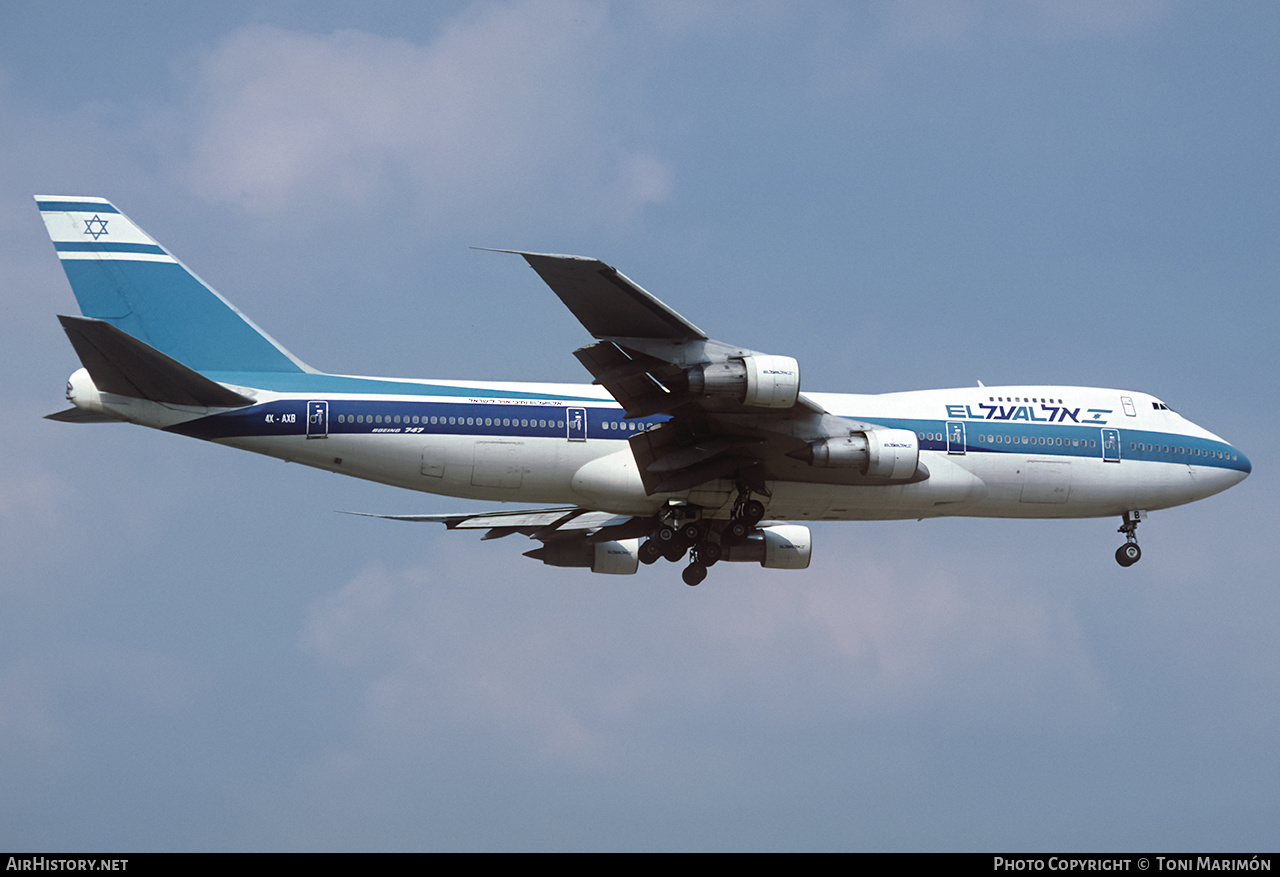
36,195,312,371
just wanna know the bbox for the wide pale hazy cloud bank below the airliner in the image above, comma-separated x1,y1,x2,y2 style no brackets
302,529,1114,764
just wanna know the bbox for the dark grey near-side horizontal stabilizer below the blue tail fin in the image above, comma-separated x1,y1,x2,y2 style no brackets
55,316,253,407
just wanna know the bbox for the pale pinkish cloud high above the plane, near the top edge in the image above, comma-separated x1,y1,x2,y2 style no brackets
188,0,669,225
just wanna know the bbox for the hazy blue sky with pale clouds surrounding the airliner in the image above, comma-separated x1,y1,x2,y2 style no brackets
0,0,1280,851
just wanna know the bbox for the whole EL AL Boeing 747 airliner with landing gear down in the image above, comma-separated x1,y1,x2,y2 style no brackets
36,196,1251,585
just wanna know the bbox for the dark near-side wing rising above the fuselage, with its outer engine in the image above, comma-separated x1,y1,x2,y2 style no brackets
502,250,911,494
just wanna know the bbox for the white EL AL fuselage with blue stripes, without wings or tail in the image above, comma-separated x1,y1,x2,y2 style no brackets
82,375,1249,521
